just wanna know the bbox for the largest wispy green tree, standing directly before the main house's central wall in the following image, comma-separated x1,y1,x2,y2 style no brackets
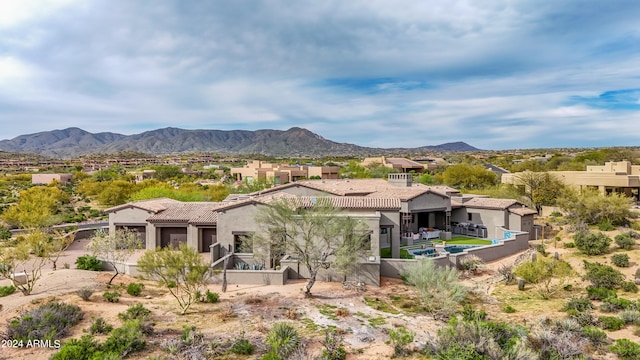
252,197,370,297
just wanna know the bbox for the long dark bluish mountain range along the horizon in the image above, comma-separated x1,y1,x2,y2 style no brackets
0,127,479,158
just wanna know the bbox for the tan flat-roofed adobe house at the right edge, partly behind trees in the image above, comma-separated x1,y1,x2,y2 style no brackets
502,161,640,201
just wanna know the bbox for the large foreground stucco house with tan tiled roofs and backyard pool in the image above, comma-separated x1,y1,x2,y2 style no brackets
106,173,536,285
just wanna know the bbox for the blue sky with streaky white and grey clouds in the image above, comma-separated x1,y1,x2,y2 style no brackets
0,0,640,150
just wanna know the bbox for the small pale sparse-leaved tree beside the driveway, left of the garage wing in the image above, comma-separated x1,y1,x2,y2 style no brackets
87,228,142,285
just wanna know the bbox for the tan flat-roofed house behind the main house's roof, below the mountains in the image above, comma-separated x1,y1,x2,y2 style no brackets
230,160,340,185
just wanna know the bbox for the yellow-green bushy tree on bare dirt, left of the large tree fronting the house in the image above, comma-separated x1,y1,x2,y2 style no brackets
138,244,211,315
